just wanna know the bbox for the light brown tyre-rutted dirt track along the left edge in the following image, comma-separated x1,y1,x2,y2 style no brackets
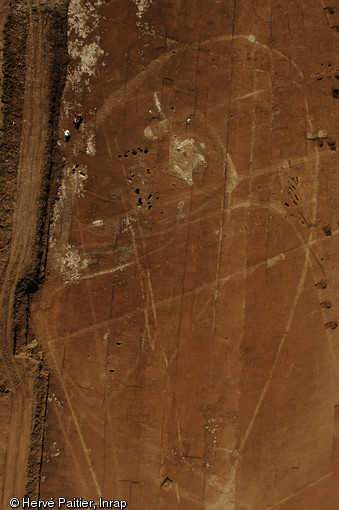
0,0,68,502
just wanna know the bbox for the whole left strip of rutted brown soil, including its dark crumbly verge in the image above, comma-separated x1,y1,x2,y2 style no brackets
0,1,66,502
